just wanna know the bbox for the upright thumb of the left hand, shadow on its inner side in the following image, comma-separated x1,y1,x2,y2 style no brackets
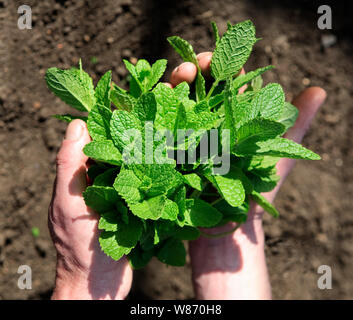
55,120,90,203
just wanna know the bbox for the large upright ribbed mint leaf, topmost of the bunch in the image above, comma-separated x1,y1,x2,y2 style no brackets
211,20,256,81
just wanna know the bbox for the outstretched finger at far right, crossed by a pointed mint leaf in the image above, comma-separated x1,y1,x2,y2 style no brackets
265,87,326,201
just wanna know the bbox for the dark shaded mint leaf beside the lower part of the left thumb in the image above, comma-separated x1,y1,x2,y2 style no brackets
83,186,120,214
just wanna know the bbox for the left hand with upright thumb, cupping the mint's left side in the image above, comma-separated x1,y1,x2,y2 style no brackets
48,120,132,300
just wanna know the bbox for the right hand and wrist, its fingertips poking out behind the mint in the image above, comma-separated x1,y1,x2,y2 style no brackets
168,52,326,299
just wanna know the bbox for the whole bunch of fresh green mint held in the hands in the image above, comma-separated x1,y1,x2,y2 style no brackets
46,21,320,268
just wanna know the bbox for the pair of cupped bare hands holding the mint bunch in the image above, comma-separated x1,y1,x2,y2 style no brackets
48,52,326,299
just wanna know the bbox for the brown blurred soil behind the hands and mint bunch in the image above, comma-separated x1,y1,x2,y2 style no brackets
0,0,353,299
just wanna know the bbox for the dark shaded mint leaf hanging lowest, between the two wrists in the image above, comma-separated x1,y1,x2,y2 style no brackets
157,238,186,267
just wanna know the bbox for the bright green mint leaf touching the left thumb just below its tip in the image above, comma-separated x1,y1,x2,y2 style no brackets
83,140,122,166
